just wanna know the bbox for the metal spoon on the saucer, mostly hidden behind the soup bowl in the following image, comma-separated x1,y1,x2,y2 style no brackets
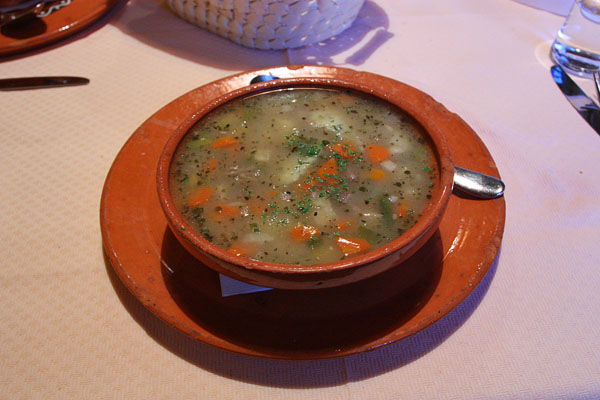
250,75,505,199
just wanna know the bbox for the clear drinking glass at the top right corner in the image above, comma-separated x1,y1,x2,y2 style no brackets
551,0,600,76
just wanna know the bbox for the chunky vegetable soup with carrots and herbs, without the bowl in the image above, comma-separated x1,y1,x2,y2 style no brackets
170,88,438,265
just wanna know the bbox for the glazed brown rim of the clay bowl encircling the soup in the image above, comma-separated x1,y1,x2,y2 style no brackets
156,77,454,274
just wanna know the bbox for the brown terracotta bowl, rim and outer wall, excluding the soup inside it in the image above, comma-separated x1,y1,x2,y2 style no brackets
157,78,454,289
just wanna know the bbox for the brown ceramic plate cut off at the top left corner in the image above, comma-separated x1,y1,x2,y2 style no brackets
0,0,119,56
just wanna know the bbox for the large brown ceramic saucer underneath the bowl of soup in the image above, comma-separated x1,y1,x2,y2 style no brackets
100,66,505,360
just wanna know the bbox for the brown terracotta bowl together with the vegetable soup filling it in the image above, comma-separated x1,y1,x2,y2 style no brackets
157,78,453,289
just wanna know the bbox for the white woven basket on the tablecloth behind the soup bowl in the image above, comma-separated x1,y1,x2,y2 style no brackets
167,0,364,50
